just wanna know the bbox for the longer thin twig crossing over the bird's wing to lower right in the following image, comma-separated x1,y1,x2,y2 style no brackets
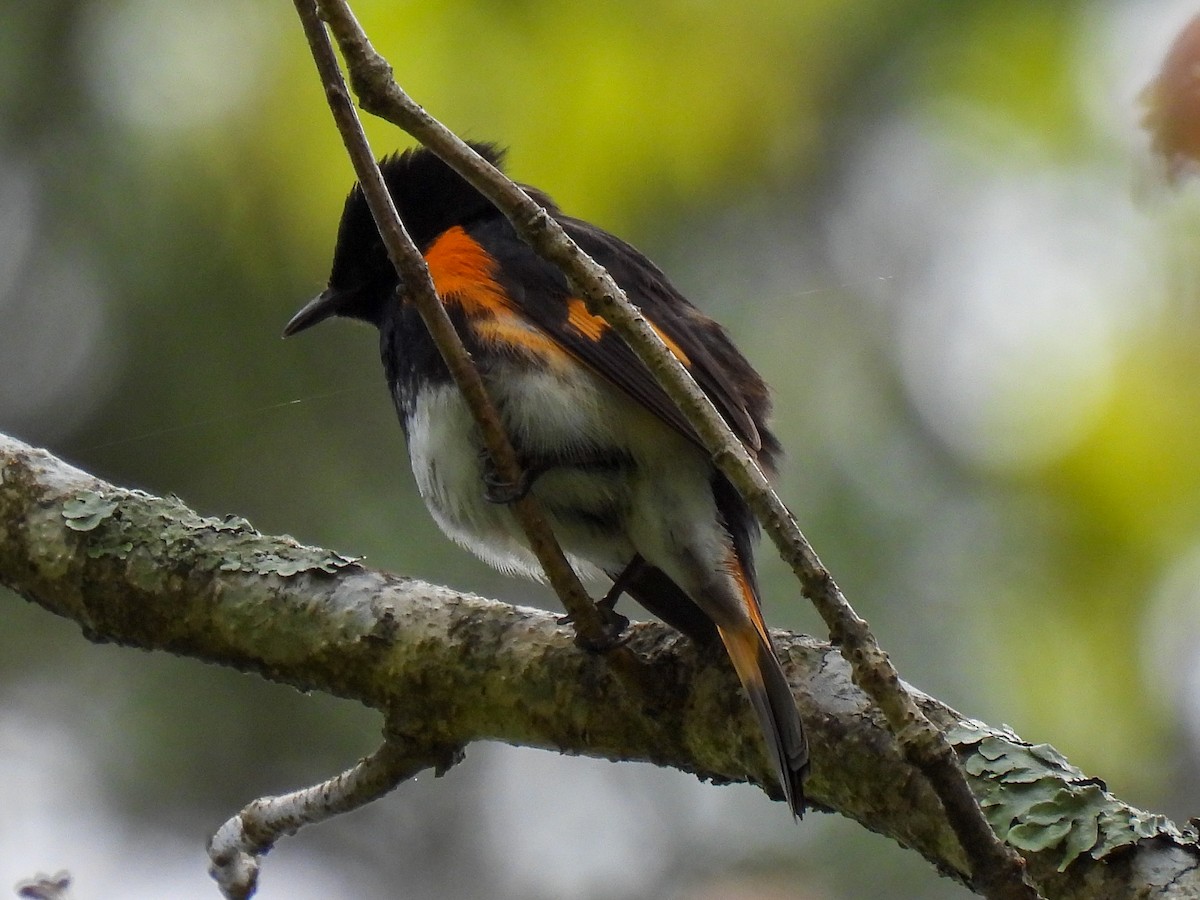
309,0,1038,898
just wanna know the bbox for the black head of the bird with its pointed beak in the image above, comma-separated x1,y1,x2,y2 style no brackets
283,143,504,337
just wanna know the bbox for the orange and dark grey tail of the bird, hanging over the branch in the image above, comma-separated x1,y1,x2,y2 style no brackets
718,556,809,817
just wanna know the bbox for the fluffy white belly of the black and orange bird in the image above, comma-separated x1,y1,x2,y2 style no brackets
408,370,720,578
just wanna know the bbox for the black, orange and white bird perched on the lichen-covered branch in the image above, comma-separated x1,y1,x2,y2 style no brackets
283,142,809,818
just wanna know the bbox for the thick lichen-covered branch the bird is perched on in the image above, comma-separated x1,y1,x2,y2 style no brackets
0,436,1200,898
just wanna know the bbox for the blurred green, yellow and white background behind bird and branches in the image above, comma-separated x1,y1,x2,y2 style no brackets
0,0,1200,900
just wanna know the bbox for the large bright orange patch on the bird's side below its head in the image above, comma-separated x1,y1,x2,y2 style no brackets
425,226,569,365
